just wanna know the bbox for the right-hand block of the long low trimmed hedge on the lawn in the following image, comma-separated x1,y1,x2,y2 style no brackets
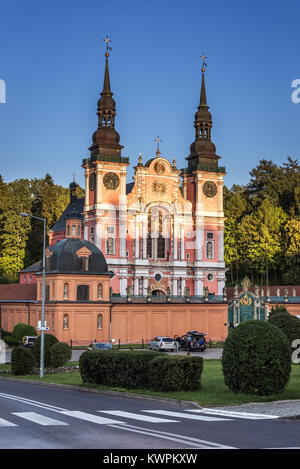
149,355,203,391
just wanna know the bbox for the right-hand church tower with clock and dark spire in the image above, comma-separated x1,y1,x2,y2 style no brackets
182,54,226,295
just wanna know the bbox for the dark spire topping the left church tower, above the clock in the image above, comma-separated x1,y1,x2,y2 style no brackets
90,36,123,161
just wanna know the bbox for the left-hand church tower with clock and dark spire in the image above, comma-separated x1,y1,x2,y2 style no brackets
82,37,129,263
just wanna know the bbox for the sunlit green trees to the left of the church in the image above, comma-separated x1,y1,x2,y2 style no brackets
0,174,83,283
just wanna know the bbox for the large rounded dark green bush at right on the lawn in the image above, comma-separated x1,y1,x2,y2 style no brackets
222,320,291,396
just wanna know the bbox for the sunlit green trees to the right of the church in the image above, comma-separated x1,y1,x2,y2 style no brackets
224,157,300,285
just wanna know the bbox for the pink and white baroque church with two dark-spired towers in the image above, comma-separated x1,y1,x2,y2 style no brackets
49,50,226,297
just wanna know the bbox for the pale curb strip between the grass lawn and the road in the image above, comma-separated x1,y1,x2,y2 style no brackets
0,376,203,409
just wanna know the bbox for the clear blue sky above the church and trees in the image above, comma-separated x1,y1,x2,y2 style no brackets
0,0,300,186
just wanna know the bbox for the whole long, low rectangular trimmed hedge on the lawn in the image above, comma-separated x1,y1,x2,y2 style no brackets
79,350,203,391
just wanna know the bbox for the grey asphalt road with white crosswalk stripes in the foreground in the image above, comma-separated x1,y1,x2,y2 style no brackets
0,379,300,450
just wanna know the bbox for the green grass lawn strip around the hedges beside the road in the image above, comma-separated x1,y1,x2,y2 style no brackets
0,360,300,406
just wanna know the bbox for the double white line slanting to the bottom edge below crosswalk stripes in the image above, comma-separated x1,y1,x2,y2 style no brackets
110,424,236,449
